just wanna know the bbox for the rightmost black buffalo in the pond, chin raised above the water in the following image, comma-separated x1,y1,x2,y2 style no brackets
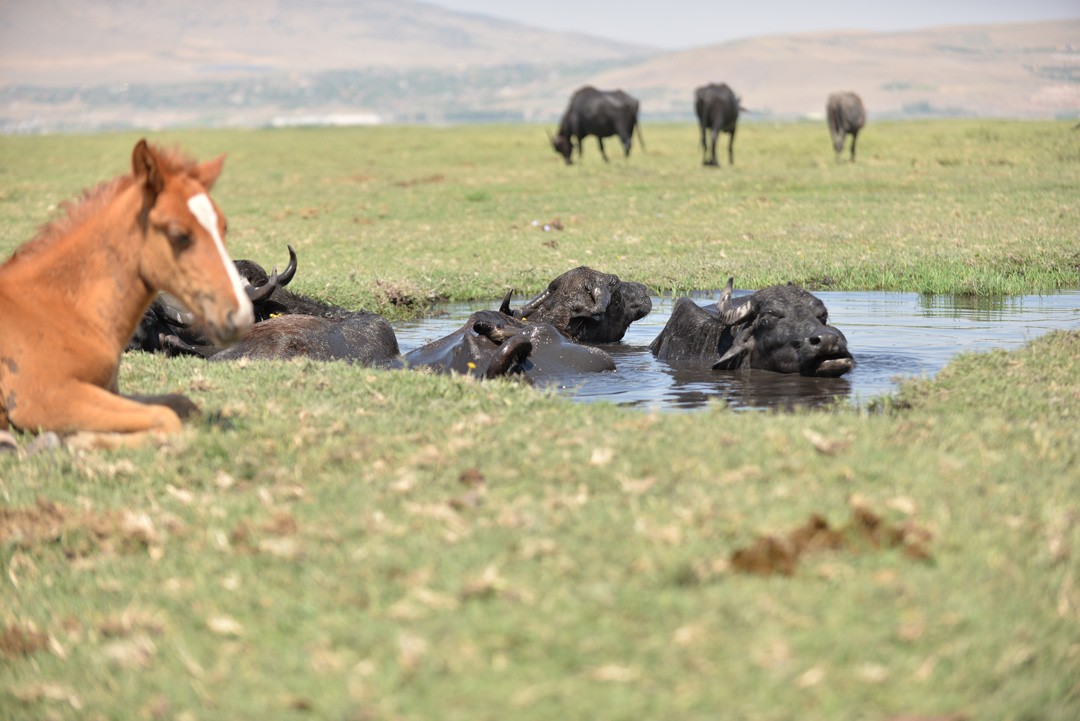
649,280,855,378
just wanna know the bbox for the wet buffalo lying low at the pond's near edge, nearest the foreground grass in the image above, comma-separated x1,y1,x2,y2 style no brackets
405,311,615,384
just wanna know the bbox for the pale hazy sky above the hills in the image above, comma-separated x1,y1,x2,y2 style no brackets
424,0,1080,50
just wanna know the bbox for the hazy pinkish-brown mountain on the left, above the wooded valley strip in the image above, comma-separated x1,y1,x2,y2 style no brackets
0,0,656,86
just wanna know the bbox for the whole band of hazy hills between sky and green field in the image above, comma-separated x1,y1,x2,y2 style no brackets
0,0,1080,134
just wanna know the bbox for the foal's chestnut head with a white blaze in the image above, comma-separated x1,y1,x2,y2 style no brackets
132,140,254,344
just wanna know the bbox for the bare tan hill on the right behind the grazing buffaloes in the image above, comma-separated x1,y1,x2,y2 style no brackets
596,19,1080,118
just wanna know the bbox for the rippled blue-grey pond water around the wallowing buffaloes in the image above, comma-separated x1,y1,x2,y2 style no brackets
394,291,1080,410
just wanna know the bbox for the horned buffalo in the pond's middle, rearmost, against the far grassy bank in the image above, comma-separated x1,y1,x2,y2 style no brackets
501,266,652,343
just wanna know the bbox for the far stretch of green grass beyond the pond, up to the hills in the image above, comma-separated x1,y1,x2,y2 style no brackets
0,121,1080,313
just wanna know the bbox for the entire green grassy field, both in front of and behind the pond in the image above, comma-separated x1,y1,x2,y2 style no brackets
0,121,1080,721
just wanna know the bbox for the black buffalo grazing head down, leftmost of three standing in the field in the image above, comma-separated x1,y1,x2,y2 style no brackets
551,85,645,165
